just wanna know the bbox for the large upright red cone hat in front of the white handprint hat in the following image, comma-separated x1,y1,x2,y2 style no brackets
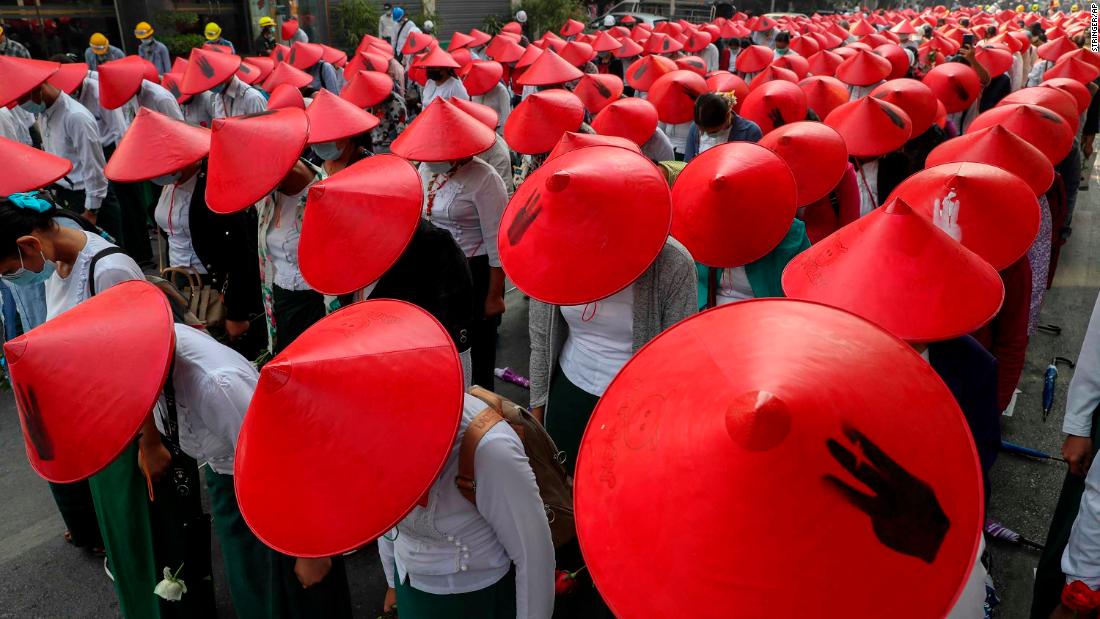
783,200,1004,342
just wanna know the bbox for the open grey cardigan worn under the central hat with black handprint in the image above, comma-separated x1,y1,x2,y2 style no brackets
528,236,697,408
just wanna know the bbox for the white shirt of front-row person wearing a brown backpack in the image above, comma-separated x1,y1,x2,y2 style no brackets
378,395,554,619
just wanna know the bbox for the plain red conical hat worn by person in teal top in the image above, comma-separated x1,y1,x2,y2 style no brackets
672,142,798,268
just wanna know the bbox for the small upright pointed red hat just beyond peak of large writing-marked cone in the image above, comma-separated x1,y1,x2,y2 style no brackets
825,97,913,157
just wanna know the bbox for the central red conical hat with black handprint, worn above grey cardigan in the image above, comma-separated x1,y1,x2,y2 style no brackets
497,146,672,306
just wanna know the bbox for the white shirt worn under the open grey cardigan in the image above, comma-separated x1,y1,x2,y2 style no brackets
558,284,634,398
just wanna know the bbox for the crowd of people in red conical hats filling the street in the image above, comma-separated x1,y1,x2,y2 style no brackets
0,4,1100,619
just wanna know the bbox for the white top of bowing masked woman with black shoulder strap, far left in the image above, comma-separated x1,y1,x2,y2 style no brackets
45,231,145,320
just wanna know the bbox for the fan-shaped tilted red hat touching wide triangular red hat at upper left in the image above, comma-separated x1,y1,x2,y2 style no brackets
206,108,309,214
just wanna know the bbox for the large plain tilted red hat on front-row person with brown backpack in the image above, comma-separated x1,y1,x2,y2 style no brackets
233,301,463,556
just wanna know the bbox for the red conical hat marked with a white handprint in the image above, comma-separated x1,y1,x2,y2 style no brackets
887,162,1040,270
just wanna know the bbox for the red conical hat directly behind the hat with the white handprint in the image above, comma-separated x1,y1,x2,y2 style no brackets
925,124,1054,196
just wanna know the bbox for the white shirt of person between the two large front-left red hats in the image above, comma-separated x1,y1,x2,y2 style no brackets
153,323,260,475
